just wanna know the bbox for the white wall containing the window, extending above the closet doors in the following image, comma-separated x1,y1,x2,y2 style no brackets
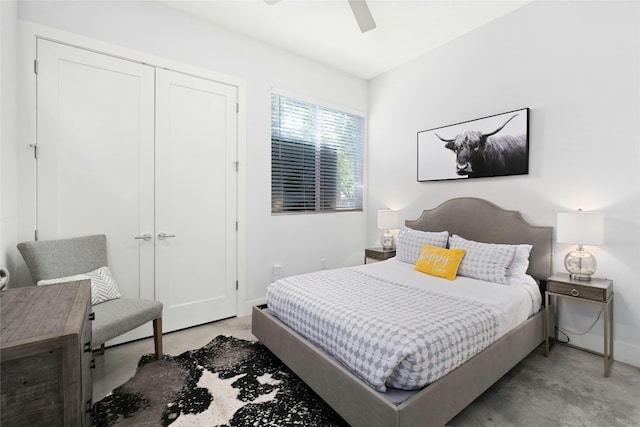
18,1,367,306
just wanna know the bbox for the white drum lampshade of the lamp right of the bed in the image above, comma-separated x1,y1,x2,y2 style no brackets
557,210,604,246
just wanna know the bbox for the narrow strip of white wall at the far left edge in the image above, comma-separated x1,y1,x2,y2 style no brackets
0,1,19,286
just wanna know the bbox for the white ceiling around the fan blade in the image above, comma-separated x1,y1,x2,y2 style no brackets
164,0,532,79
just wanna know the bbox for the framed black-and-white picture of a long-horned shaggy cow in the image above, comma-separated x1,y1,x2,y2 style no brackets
418,108,529,182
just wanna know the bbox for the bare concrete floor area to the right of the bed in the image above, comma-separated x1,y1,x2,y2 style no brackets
449,345,640,427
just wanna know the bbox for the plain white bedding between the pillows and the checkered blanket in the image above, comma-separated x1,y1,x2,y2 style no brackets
353,258,542,337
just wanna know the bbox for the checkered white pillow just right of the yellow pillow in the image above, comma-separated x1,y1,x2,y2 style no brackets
449,234,516,285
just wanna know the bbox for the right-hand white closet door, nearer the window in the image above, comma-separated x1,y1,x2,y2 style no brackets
155,69,237,331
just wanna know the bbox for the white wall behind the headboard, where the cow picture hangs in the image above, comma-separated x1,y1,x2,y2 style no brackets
368,1,640,369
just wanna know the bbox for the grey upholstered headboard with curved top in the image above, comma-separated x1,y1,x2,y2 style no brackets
405,197,553,280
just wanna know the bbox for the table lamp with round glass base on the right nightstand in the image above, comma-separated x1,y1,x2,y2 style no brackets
557,210,604,280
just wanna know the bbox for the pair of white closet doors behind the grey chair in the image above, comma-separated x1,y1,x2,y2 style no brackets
36,40,237,343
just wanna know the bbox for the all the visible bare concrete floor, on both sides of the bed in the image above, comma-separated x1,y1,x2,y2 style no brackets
93,316,640,427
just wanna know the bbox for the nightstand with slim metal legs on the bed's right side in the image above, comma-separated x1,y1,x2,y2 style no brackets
544,273,613,377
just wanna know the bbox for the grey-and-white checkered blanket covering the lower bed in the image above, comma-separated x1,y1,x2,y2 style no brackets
267,268,498,391
